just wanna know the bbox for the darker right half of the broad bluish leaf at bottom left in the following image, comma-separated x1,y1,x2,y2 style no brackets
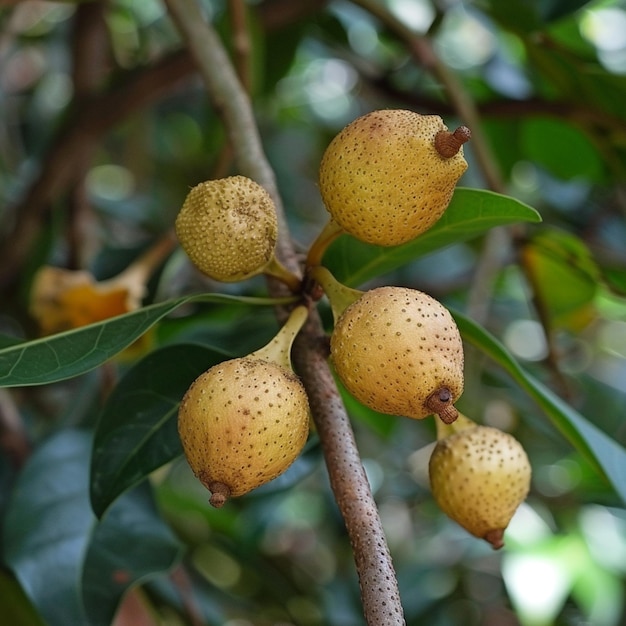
82,483,182,626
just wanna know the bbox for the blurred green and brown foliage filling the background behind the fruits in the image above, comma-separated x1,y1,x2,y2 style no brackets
0,0,626,626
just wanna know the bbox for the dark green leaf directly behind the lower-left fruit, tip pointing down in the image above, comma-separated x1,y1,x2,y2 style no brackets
91,344,229,517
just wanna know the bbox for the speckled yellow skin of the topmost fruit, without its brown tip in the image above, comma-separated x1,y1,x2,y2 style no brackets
319,109,467,246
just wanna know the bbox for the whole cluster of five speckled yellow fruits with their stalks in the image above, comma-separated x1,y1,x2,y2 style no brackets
176,110,530,548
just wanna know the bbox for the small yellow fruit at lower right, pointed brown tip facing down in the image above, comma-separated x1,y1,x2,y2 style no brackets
429,425,531,549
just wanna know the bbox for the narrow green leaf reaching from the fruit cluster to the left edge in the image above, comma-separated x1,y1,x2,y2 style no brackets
0,294,293,387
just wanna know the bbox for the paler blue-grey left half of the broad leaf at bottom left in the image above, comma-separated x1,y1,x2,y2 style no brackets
4,430,95,626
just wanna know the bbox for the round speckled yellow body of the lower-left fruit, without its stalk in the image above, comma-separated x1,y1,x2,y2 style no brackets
178,357,309,496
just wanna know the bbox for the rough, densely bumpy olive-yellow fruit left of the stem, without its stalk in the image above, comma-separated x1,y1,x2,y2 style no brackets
175,176,278,282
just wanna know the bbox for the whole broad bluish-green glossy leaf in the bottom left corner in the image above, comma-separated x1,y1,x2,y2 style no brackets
3,430,179,626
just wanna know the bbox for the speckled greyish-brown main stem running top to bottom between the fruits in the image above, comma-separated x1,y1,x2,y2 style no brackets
161,0,405,626
